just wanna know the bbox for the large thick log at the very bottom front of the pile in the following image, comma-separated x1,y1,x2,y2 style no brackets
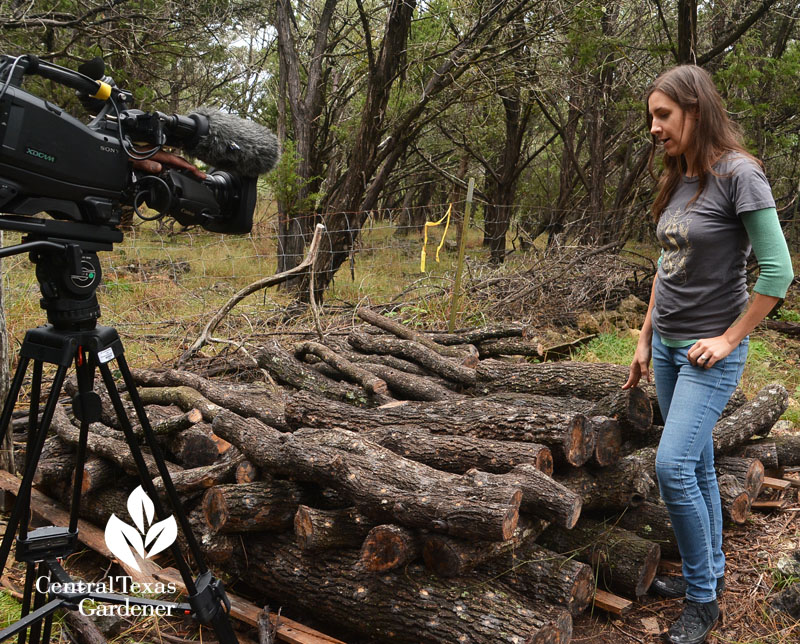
245,536,572,644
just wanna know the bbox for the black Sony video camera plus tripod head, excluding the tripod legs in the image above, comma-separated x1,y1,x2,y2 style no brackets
0,55,278,330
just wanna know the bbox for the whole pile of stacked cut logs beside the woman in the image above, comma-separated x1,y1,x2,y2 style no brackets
18,310,800,644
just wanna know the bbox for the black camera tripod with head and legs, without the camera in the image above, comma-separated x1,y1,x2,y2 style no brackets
0,217,237,644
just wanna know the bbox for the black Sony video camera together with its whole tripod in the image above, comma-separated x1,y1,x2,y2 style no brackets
0,56,278,644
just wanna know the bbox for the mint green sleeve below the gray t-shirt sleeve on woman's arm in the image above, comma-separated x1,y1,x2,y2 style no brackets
741,208,794,297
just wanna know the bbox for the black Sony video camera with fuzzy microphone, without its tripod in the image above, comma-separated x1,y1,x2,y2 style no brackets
0,55,278,233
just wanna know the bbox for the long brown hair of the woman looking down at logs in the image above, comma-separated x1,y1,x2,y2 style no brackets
645,65,764,221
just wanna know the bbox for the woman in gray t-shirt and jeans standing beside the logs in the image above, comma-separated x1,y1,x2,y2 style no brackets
623,65,793,644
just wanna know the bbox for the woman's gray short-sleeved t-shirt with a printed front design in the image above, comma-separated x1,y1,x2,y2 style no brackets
653,154,775,340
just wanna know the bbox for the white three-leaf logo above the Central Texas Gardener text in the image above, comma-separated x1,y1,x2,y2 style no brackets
105,485,178,572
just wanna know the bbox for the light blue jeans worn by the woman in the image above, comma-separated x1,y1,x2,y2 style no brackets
653,330,749,602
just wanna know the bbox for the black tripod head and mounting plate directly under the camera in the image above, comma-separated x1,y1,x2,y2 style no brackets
0,216,122,331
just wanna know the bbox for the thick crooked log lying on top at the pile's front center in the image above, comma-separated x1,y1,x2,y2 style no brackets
214,413,522,540
